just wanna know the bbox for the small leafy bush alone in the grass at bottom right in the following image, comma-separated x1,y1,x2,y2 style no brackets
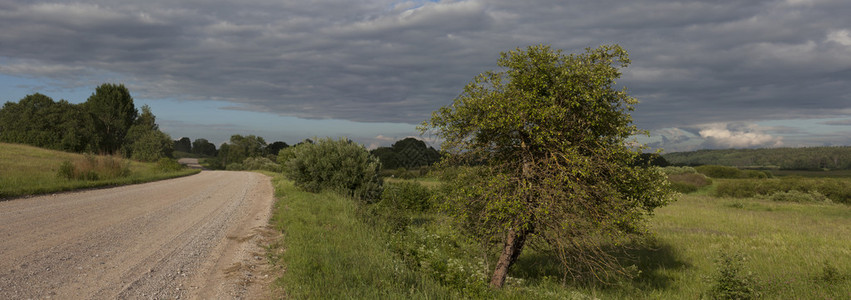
708,253,759,300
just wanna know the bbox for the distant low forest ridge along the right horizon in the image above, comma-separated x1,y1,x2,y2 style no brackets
662,146,851,170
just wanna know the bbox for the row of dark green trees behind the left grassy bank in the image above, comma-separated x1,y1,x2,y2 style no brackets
0,83,173,161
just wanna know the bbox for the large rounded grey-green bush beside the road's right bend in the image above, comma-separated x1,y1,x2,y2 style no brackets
283,138,381,202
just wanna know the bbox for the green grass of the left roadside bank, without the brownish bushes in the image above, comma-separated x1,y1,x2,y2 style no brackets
0,143,200,199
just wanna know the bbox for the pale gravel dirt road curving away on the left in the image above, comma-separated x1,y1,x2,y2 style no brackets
0,171,273,299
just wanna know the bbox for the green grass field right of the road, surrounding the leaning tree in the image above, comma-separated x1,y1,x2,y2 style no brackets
270,176,851,299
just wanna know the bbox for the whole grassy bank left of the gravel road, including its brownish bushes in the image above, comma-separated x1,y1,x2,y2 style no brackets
0,143,199,199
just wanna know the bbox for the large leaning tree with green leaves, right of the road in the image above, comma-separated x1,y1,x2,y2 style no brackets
420,45,671,287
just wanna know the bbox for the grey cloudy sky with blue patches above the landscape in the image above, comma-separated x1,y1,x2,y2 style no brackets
0,0,851,152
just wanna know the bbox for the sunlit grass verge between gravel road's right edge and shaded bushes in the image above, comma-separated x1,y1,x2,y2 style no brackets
270,176,452,299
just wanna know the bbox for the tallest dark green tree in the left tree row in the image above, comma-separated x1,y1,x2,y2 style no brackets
84,83,139,153
